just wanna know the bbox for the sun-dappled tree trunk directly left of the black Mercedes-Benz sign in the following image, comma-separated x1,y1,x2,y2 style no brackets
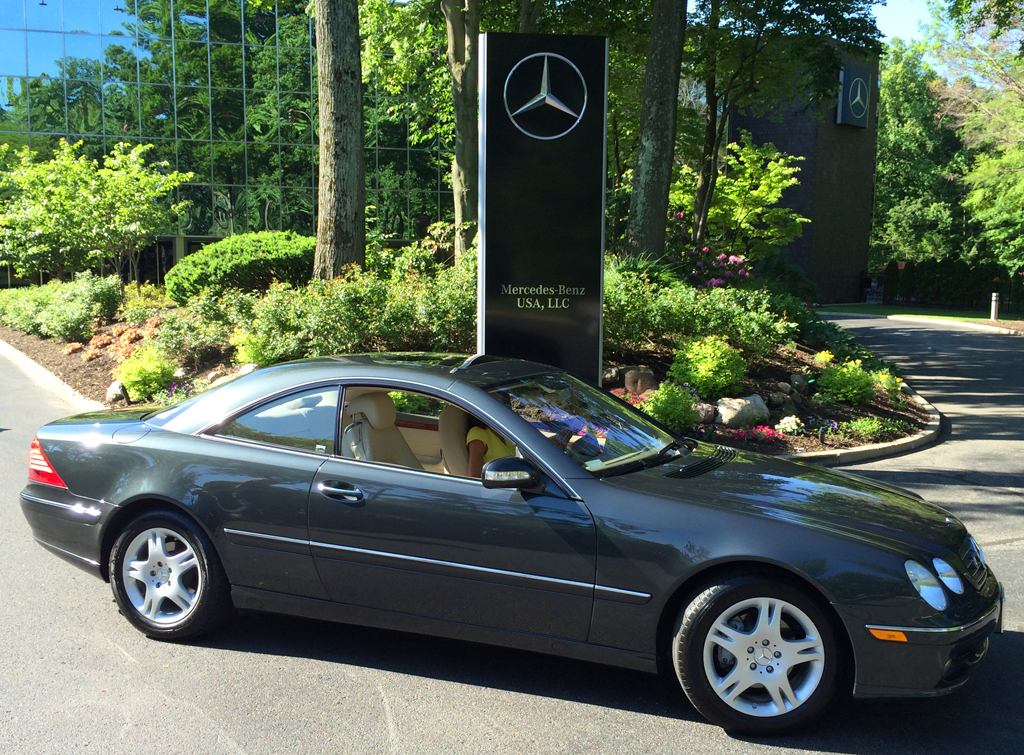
440,0,480,260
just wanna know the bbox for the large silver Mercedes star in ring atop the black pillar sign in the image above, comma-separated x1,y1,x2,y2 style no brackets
504,52,587,139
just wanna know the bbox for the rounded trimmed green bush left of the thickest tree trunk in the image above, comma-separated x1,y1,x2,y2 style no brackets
166,230,316,305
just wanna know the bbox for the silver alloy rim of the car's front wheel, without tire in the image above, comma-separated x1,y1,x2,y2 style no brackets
703,597,825,717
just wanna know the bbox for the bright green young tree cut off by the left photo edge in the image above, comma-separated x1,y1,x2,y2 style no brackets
0,139,101,281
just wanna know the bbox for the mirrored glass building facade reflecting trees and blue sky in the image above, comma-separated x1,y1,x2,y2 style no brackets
0,0,452,245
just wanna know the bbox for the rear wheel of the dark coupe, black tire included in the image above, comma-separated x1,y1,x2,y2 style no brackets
110,511,231,640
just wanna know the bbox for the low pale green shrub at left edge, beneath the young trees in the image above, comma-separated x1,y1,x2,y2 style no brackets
0,271,121,341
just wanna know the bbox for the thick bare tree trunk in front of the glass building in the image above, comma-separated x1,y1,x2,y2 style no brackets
313,0,367,280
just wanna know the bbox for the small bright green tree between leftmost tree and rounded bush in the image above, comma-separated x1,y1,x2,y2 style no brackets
91,142,193,289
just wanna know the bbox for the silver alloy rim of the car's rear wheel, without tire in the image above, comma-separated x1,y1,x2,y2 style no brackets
123,527,204,627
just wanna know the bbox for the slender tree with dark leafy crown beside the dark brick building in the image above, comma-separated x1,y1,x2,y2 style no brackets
683,0,879,244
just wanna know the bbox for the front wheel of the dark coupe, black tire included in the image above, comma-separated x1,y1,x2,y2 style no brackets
672,575,840,735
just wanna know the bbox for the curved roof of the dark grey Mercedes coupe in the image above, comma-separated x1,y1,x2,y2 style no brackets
146,351,560,433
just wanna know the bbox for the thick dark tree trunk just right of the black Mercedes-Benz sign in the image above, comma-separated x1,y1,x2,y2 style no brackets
626,0,686,256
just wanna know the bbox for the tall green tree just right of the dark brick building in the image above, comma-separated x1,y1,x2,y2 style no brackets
871,39,976,266
